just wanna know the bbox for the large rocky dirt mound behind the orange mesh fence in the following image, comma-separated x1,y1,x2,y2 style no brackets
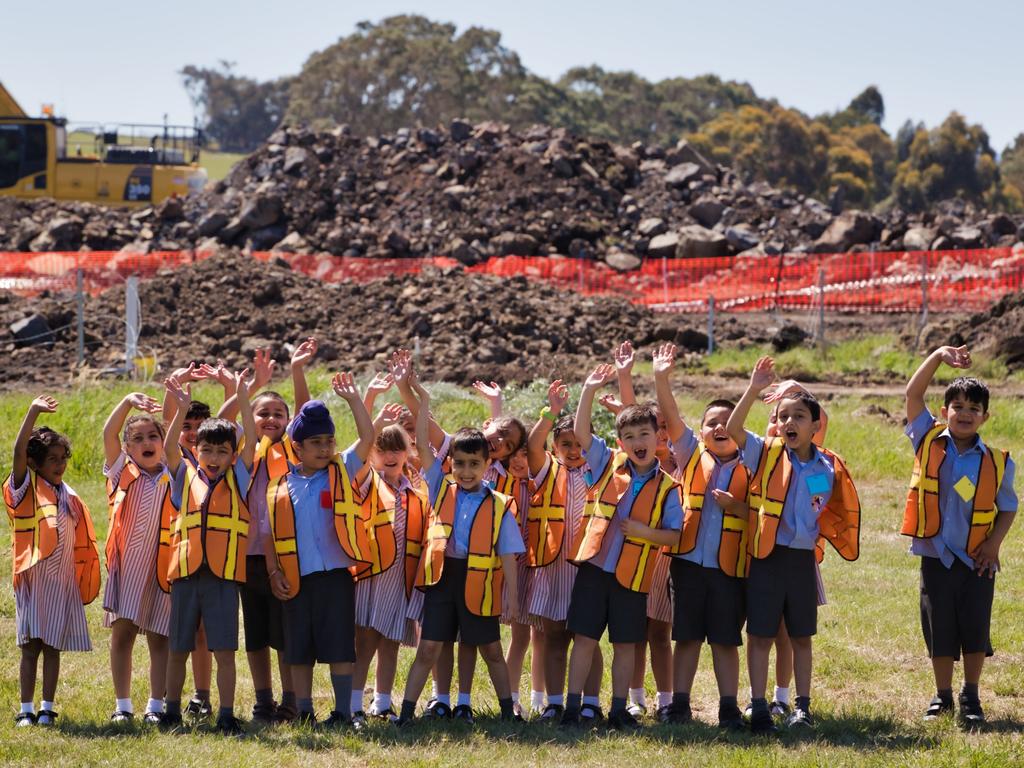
0,120,1024,262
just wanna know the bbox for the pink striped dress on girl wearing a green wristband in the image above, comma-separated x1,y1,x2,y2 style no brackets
528,456,587,622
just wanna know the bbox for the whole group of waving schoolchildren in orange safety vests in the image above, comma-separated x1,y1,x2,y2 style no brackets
3,339,1017,733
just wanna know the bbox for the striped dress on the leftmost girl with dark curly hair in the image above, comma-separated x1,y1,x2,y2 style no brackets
11,479,92,650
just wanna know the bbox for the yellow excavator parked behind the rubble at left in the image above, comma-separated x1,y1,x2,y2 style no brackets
0,83,207,207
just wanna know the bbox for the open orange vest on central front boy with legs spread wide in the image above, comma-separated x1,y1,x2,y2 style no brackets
415,477,515,616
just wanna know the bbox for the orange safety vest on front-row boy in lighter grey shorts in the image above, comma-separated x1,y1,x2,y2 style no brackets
167,464,249,583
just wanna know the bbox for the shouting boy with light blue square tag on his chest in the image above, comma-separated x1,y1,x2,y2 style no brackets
727,357,860,733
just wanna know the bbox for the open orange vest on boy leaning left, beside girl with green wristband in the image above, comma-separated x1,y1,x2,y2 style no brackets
568,451,679,594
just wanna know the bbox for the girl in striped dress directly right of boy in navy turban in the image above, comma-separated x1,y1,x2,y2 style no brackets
351,403,427,723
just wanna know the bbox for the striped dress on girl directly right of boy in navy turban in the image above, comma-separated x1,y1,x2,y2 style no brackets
355,475,422,646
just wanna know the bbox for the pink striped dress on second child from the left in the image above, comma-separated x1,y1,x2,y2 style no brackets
103,452,171,637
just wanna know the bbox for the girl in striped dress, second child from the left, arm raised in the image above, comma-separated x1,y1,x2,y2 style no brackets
103,392,174,724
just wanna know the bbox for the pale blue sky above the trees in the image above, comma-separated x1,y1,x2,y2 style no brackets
0,0,1024,152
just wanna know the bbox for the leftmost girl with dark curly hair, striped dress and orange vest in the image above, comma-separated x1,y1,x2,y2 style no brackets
3,395,99,726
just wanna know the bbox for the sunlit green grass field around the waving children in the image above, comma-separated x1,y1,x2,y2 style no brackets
0,348,1024,767
